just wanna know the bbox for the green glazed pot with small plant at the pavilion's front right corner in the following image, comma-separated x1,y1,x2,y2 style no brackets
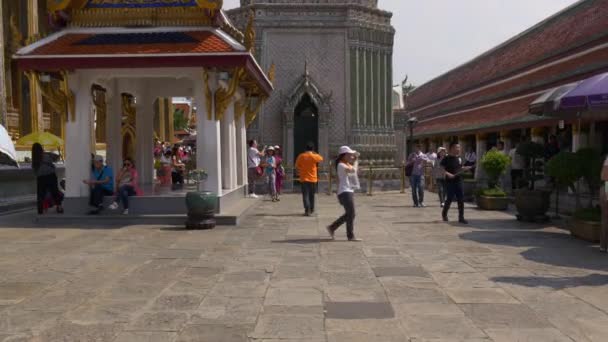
186,170,217,229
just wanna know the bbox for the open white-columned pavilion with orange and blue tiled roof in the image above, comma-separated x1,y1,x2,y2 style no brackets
9,0,272,214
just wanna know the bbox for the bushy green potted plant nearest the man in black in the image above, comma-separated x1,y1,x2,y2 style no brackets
476,150,511,210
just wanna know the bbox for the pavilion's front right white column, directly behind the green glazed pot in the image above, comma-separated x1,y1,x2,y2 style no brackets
194,73,222,195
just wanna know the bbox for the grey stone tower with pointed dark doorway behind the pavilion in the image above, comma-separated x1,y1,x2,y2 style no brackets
228,0,395,165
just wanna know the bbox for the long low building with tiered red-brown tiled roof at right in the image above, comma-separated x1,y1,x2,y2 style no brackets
399,0,608,167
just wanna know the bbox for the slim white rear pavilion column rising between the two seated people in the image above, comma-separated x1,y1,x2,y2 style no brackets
106,79,122,175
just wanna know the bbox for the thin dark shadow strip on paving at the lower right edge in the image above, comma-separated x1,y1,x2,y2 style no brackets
491,273,608,290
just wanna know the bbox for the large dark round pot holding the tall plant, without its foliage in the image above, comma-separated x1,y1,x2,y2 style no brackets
515,189,551,222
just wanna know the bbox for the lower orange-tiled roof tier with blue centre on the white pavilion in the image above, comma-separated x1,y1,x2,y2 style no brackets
14,27,272,95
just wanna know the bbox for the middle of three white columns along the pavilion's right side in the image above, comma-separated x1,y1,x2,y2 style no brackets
220,100,237,190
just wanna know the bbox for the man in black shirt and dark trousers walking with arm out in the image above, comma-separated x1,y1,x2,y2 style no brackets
441,142,472,224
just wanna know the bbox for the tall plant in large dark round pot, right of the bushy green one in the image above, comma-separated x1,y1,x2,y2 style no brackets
515,141,551,222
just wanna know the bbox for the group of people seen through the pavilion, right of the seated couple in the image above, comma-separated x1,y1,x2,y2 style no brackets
154,141,192,188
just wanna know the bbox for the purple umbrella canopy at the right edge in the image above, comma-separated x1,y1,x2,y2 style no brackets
560,73,608,111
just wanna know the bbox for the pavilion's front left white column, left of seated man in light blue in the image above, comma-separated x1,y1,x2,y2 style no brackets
65,74,93,197
